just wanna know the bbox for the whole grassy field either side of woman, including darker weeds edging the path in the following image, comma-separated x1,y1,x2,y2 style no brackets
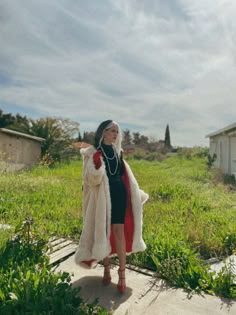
0,156,236,297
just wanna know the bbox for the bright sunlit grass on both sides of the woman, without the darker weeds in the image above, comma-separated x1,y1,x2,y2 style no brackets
0,157,236,258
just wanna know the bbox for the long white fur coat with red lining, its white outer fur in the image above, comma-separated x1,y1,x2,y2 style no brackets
75,146,148,267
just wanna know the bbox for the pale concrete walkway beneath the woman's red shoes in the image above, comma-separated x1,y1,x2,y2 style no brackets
56,256,236,315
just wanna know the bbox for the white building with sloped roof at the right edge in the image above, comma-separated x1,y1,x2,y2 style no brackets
206,123,236,176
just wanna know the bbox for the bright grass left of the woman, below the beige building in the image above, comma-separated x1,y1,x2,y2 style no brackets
0,162,82,237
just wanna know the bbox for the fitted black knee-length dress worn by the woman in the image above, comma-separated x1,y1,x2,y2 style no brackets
102,144,127,224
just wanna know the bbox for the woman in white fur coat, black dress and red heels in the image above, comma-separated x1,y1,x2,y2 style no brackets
75,120,148,293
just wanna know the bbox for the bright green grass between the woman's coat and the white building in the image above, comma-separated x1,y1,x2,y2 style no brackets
131,157,236,258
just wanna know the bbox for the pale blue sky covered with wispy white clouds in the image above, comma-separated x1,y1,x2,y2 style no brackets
0,0,236,147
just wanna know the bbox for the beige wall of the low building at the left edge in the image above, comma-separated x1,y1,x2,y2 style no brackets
0,132,41,171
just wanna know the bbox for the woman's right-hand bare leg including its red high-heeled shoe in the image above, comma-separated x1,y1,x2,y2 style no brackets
113,224,126,288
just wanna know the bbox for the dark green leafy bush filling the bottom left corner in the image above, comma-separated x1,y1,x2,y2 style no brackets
0,219,107,315
